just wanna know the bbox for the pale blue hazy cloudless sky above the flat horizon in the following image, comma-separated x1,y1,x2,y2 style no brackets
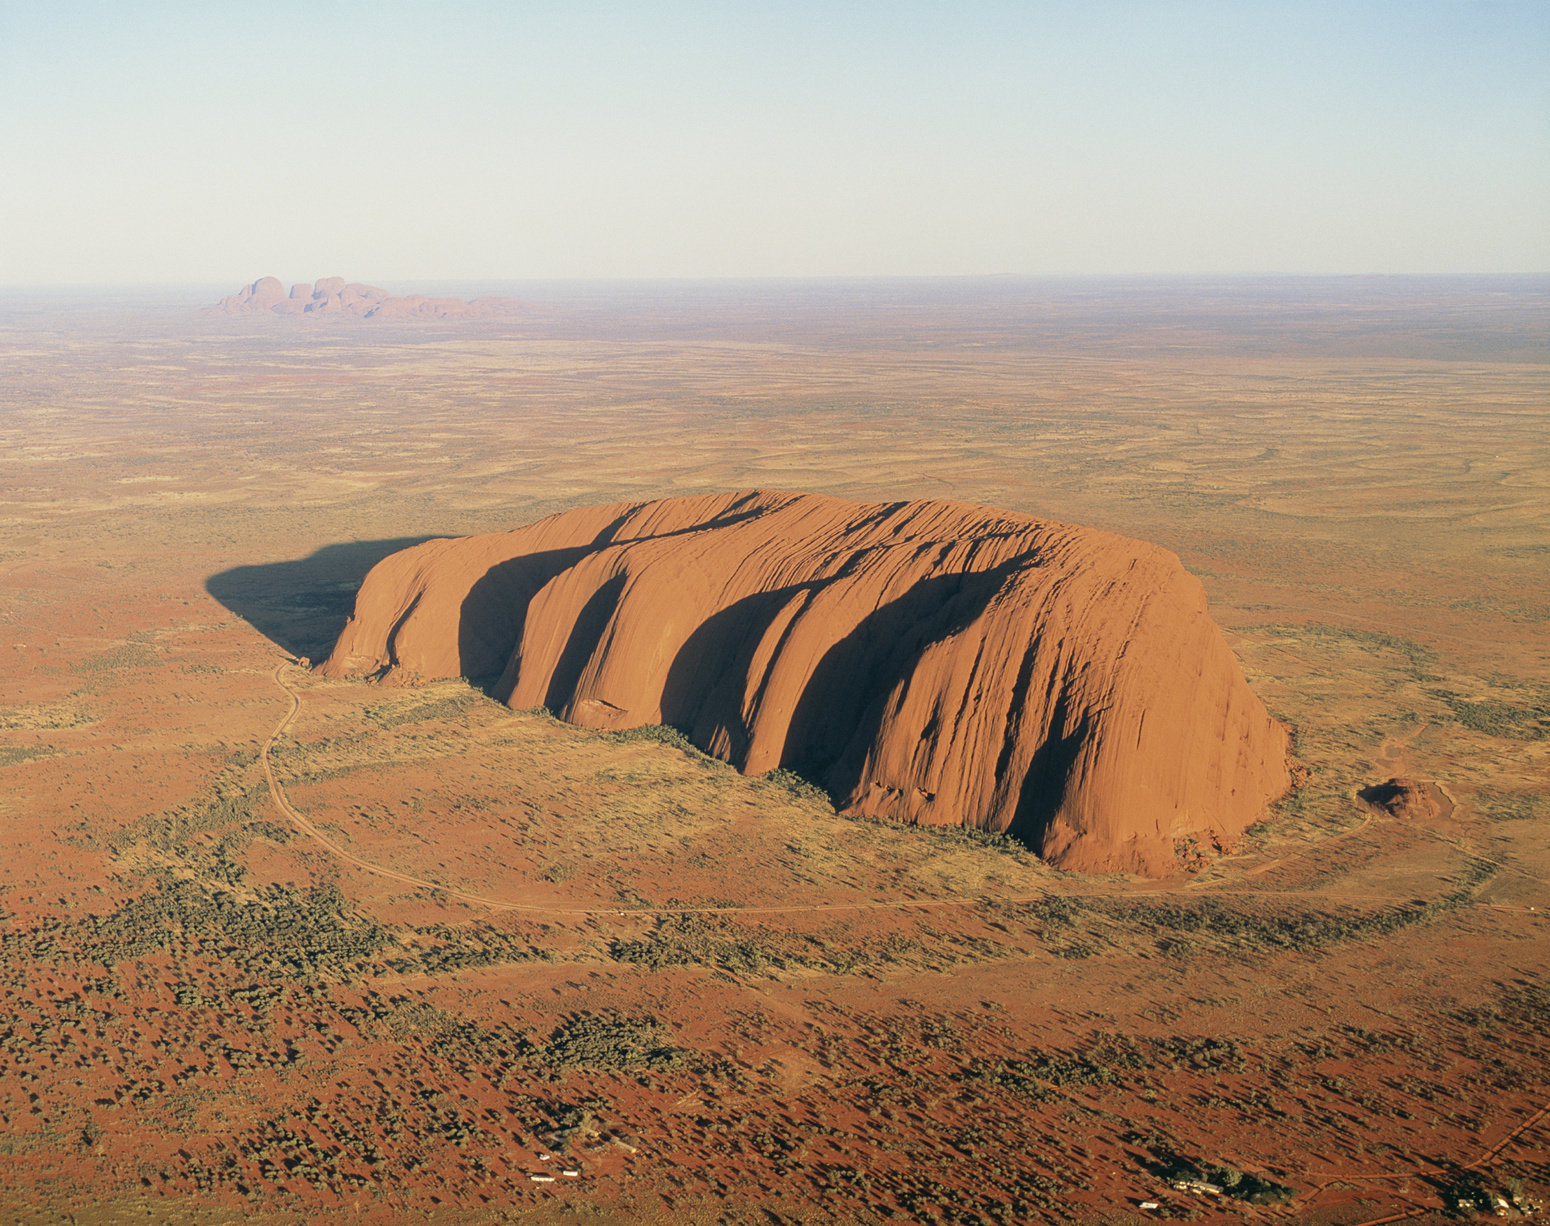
0,0,1550,285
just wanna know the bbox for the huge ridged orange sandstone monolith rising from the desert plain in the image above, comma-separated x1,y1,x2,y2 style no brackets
322,491,1291,876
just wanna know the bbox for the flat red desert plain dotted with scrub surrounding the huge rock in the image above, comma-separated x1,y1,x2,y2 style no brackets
0,277,1550,1226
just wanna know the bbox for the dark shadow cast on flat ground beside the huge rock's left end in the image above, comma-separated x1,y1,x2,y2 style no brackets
205,536,434,662
